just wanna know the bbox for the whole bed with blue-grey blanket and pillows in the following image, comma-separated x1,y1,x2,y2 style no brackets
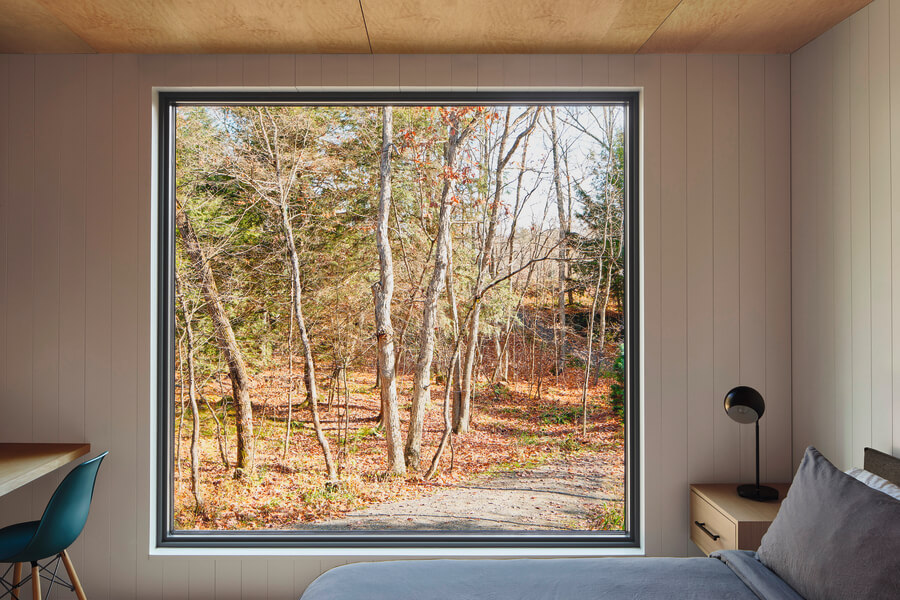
301,447,900,600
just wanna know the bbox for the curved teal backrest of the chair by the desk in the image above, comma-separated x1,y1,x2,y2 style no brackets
23,452,109,558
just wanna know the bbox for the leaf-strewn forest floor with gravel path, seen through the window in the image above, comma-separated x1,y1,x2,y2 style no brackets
175,310,624,530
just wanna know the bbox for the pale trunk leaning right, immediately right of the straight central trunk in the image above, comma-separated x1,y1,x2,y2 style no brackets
406,115,471,469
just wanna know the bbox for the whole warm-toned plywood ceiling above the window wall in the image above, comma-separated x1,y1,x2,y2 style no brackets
0,0,870,54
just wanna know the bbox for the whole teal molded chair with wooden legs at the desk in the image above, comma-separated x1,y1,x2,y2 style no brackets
0,452,108,600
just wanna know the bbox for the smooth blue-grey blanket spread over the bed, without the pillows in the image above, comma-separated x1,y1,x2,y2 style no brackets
301,553,802,600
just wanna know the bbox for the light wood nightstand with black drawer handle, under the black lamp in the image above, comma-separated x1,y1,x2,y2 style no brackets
691,483,790,554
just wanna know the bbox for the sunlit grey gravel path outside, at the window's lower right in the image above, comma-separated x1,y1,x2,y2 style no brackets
303,453,622,531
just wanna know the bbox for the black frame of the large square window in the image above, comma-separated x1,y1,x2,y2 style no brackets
151,90,642,550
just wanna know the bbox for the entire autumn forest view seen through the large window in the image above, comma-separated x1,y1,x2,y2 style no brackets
172,104,627,530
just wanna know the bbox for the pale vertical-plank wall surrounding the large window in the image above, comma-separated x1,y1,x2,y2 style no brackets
0,55,788,599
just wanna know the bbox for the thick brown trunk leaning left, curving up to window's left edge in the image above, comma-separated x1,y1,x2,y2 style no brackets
175,207,253,475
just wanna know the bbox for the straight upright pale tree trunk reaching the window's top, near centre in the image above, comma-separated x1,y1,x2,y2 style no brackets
372,106,406,475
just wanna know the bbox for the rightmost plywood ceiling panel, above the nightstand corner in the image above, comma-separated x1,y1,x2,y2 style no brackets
641,0,870,54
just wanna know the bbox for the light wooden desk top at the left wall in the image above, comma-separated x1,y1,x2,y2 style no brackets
0,444,91,496
